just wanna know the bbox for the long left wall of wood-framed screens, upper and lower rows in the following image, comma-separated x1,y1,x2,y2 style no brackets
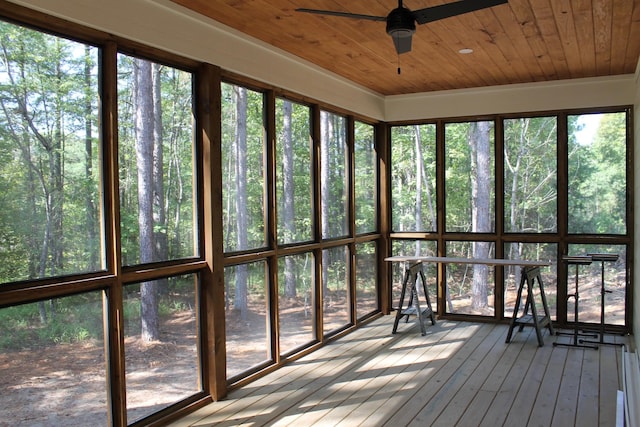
0,8,382,425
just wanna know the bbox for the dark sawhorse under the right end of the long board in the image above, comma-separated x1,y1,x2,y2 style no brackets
505,267,554,347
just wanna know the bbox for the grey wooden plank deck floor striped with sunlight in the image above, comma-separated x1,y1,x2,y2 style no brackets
174,316,626,427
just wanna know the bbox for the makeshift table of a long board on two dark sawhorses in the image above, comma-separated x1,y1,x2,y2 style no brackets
385,255,553,346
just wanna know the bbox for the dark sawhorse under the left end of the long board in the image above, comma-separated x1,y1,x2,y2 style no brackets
392,263,436,335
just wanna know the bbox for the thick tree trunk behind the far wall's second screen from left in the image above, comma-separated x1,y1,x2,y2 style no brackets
469,122,491,309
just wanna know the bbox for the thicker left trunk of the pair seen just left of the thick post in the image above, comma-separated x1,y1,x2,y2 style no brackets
134,59,160,342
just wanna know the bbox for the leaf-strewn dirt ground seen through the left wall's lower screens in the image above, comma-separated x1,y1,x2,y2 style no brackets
0,304,352,427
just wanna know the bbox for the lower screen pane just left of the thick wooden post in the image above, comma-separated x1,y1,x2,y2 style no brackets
123,274,202,423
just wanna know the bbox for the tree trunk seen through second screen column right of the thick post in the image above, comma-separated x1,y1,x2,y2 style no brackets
282,101,296,298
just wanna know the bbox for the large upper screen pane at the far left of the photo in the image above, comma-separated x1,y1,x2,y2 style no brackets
0,22,106,283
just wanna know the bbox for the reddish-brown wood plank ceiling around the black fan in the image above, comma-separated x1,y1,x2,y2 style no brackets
172,0,640,95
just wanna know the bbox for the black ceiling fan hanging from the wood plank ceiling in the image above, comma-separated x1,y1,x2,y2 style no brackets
296,0,508,54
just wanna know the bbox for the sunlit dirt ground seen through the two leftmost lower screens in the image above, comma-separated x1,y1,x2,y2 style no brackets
0,312,198,427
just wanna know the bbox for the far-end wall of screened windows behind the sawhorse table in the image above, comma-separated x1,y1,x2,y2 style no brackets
390,110,632,328
